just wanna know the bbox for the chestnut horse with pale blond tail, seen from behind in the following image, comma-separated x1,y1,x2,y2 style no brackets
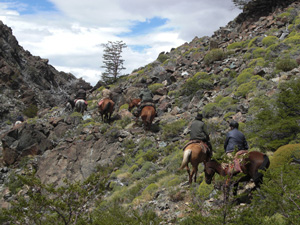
179,142,211,184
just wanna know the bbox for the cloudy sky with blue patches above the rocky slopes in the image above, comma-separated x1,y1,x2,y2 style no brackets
0,0,240,85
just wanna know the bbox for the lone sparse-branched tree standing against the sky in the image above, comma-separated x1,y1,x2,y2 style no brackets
102,41,127,83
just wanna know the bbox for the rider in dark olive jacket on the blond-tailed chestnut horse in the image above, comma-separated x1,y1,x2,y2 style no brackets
190,113,212,151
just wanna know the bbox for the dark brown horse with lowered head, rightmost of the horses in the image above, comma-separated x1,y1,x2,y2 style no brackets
204,151,270,195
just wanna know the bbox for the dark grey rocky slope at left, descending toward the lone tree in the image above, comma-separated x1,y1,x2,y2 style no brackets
0,21,91,131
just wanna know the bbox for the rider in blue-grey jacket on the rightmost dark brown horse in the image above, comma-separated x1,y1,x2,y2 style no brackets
224,121,249,154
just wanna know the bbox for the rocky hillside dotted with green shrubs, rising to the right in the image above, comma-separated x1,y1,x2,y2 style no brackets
0,1,300,224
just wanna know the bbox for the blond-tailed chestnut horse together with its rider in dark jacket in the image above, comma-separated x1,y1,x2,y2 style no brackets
179,113,212,183
